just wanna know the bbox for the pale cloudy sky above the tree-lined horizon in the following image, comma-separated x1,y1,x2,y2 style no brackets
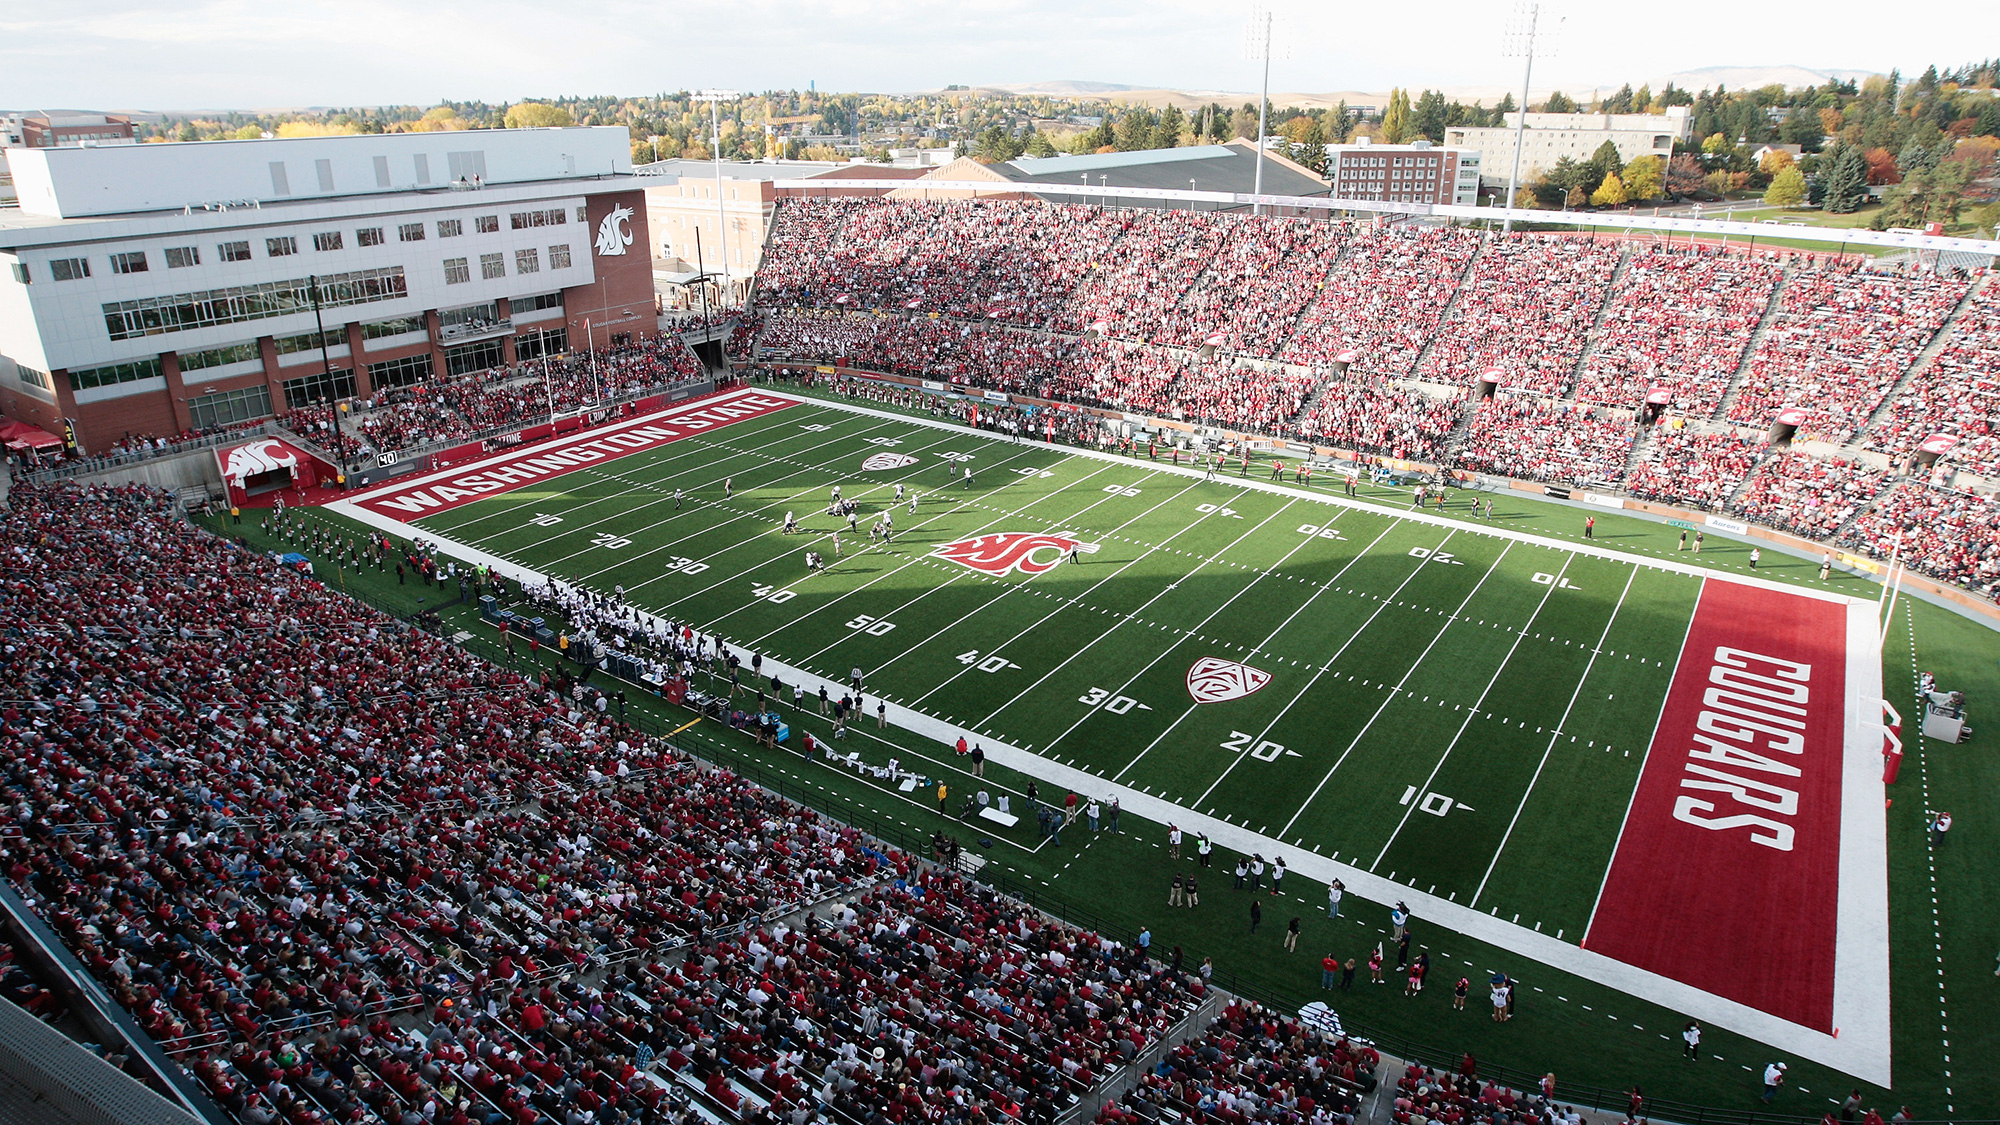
0,0,2000,110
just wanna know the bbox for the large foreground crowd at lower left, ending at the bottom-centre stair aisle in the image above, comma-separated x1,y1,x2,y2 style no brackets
0,484,1202,1123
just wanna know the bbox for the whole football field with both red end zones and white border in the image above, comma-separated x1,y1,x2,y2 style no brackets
338,392,1888,1073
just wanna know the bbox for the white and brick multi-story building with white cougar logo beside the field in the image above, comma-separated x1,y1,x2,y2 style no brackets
0,128,656,448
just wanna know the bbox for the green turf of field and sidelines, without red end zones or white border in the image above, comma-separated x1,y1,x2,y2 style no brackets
232,382,2000,1119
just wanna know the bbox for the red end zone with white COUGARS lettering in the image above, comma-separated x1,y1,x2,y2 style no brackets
1584,579,1848,1033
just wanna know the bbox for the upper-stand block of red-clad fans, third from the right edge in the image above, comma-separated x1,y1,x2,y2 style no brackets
1576,246,1784,418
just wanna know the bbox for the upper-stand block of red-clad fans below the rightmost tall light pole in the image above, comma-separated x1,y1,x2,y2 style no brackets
1416,234,1624,396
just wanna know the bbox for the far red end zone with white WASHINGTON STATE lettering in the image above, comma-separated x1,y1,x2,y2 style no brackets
354,392,794,522
